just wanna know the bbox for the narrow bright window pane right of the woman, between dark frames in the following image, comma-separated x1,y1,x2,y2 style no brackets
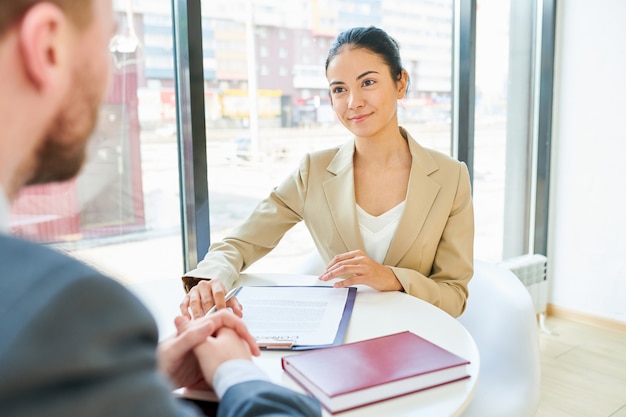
474,0,535,261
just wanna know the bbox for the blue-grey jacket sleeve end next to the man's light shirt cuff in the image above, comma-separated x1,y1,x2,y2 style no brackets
217,381,322,417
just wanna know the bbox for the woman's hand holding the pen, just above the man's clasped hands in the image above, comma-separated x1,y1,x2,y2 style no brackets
180,279,243,319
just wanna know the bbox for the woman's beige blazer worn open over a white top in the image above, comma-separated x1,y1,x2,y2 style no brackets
183,128,474,317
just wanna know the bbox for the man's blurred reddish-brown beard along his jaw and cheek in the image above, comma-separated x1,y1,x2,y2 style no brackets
27,71,101,185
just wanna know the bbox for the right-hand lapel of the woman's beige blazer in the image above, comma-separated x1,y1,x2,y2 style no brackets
384,129,441,265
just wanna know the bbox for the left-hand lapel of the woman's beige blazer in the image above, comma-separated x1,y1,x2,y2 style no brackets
323,140,365,250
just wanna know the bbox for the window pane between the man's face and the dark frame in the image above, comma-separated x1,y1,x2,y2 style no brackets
10,0,183,283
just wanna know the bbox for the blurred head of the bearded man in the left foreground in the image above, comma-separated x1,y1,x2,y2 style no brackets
0,0,115,196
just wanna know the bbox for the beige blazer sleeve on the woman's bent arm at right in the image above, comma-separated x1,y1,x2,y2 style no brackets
390,163,474,317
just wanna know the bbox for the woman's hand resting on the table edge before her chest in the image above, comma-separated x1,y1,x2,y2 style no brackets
319,250,402,291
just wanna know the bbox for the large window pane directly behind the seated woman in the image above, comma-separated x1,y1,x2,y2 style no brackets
202,0,453,272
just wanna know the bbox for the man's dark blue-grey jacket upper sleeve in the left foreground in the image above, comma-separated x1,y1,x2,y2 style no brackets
0,255,201,417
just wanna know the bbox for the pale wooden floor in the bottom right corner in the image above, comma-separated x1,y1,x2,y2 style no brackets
536,317,626,417
